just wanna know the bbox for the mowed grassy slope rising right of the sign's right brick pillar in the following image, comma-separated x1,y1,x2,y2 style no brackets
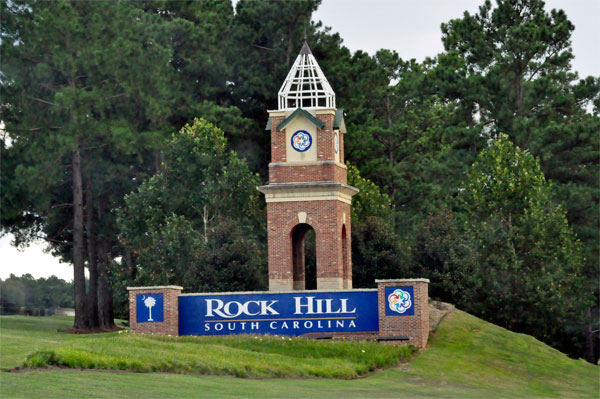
408,310,600,398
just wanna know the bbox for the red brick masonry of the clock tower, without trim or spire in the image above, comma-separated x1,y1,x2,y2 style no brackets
267,110,352,291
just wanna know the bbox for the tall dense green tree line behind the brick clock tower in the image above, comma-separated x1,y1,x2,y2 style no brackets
0,0,600,361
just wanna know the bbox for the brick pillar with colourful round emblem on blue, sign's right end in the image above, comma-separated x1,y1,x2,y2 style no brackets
375,278,429,348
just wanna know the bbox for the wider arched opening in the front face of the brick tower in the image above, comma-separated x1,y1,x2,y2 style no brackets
292,223,317,290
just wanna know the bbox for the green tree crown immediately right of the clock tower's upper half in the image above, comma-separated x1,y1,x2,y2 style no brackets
340,50,483,234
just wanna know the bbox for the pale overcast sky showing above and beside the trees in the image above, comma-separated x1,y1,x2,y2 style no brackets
0,0,600,280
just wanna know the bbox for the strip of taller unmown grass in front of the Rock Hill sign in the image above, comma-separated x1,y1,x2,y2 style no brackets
23,334,413,379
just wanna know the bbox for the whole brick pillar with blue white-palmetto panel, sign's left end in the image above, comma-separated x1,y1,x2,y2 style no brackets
127,285,183,336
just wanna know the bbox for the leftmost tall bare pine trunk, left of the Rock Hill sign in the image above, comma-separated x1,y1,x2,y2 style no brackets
71,142,89,330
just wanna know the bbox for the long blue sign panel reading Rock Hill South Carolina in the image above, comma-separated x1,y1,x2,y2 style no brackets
179,290,379,335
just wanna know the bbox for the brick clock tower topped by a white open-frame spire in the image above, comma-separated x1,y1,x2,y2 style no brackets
258,42,358,291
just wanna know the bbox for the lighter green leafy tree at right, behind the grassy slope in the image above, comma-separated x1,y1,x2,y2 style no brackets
461,135,590,354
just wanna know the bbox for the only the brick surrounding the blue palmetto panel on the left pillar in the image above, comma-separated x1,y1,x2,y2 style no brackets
127,285,183,336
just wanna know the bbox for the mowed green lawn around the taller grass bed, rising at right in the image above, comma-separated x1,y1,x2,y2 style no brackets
0,311,600,399
